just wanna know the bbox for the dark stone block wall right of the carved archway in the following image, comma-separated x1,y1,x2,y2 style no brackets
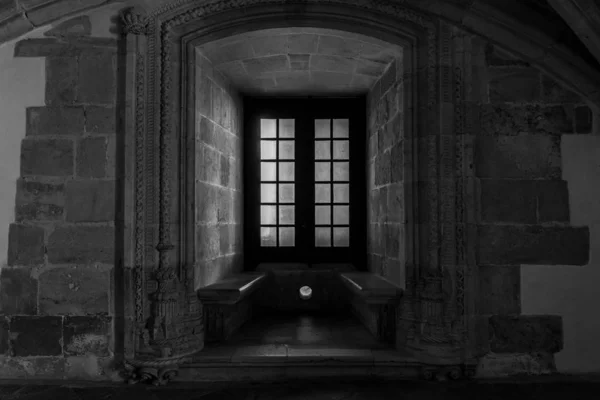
471,41,594,374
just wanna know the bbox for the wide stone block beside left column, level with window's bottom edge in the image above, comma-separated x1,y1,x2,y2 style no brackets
48,226,115,264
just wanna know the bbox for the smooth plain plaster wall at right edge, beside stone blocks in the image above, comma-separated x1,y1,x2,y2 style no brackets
521,134,600,372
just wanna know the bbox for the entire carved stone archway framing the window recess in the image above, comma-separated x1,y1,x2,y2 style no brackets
120,0,477,381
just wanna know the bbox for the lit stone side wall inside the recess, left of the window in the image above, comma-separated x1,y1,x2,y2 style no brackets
195,53,243,288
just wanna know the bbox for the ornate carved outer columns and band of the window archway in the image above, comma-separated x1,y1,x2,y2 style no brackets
122,0,476,383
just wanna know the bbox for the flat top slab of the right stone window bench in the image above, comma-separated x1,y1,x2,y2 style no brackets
339,272,404,304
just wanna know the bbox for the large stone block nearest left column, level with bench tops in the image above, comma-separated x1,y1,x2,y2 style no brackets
39,264,110,315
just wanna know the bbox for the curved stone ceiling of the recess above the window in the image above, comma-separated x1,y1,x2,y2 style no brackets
197,28,402,95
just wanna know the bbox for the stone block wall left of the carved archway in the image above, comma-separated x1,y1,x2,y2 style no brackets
0,17,117,379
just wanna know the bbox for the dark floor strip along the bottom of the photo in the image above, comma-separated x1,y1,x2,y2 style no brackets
0,376,600,400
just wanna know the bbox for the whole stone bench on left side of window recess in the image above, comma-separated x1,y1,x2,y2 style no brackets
196,272,267,342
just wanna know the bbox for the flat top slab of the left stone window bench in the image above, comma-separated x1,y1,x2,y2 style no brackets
196,272,267,304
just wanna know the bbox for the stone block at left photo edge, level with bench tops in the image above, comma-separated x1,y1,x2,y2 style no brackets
0,267,38,316
